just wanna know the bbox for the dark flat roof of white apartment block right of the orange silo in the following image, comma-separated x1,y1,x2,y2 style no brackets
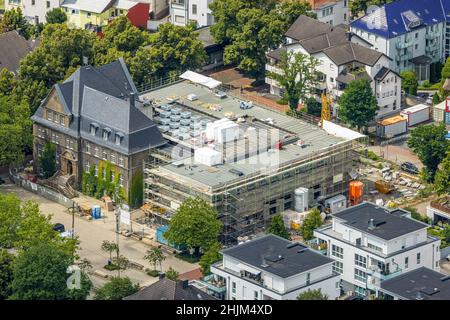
333,202,428,240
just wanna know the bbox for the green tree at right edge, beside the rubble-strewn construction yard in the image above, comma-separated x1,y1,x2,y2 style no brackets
407,124,449,182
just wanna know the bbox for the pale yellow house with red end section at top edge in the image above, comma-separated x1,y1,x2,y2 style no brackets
61,0,150,32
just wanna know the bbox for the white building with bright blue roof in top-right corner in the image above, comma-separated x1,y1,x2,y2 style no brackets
350,0,450,81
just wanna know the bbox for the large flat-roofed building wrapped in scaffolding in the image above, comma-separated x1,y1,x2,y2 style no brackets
141,72,365,244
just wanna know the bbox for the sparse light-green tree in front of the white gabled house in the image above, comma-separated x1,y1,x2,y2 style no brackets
267,51,319,112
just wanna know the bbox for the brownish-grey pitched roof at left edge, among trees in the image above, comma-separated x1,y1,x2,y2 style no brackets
0,30,32,72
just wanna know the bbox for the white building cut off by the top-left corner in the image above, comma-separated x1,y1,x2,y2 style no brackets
5,0,63,23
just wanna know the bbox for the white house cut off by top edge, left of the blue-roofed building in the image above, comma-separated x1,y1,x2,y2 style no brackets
309,0,350,26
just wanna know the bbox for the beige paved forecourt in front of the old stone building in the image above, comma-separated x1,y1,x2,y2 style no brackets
0,183,198,287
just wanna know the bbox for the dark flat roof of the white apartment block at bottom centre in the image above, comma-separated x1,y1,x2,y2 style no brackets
222,235,333,278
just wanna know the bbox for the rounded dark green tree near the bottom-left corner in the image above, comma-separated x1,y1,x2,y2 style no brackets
11,243,72,300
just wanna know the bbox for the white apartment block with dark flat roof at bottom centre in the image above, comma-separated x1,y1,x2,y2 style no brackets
211,235,340,300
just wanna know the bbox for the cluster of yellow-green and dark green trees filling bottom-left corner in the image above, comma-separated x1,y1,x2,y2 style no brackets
0,194,92,300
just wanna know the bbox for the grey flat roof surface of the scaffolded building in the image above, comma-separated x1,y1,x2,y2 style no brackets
141,81,352,187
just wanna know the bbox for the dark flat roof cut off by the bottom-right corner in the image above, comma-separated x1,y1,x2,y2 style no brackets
381,267,450,300
